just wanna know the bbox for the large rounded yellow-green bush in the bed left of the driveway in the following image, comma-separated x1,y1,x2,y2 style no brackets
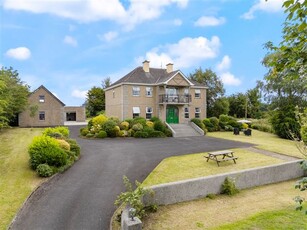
28,136,67,170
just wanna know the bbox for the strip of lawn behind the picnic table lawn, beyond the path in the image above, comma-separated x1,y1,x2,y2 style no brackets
207,130,303,158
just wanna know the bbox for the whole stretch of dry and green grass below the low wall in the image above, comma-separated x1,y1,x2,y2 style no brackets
143,181,307,230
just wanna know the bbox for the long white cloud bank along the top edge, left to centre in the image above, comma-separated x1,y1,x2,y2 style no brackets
3,0,189,29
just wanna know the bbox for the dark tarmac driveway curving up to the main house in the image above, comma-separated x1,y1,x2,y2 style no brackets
11,126,251,230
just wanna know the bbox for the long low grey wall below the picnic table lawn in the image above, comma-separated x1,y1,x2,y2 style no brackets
144,160,306,205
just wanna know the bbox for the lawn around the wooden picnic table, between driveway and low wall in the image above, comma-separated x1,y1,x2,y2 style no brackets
143,149,283,186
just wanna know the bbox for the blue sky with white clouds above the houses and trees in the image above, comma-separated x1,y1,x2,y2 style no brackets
0,0,286,106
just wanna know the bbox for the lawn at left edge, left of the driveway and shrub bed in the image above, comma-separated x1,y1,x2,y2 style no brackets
0,128,43,229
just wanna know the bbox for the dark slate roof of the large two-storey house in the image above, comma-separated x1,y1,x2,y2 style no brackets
107,66,205,89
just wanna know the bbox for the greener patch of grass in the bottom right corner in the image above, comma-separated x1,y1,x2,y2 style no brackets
213,208,307,230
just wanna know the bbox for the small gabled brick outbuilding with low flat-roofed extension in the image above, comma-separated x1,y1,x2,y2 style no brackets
18,85,85,127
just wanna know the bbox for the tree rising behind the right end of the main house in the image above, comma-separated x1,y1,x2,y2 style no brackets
189,68,225,117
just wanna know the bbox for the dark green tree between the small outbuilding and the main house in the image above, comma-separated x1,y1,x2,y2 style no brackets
86,86,105,116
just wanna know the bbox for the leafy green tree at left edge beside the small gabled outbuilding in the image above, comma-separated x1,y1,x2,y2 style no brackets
0,67,29,126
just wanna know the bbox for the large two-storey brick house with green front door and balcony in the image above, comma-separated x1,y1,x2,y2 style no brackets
105,61,207,123
